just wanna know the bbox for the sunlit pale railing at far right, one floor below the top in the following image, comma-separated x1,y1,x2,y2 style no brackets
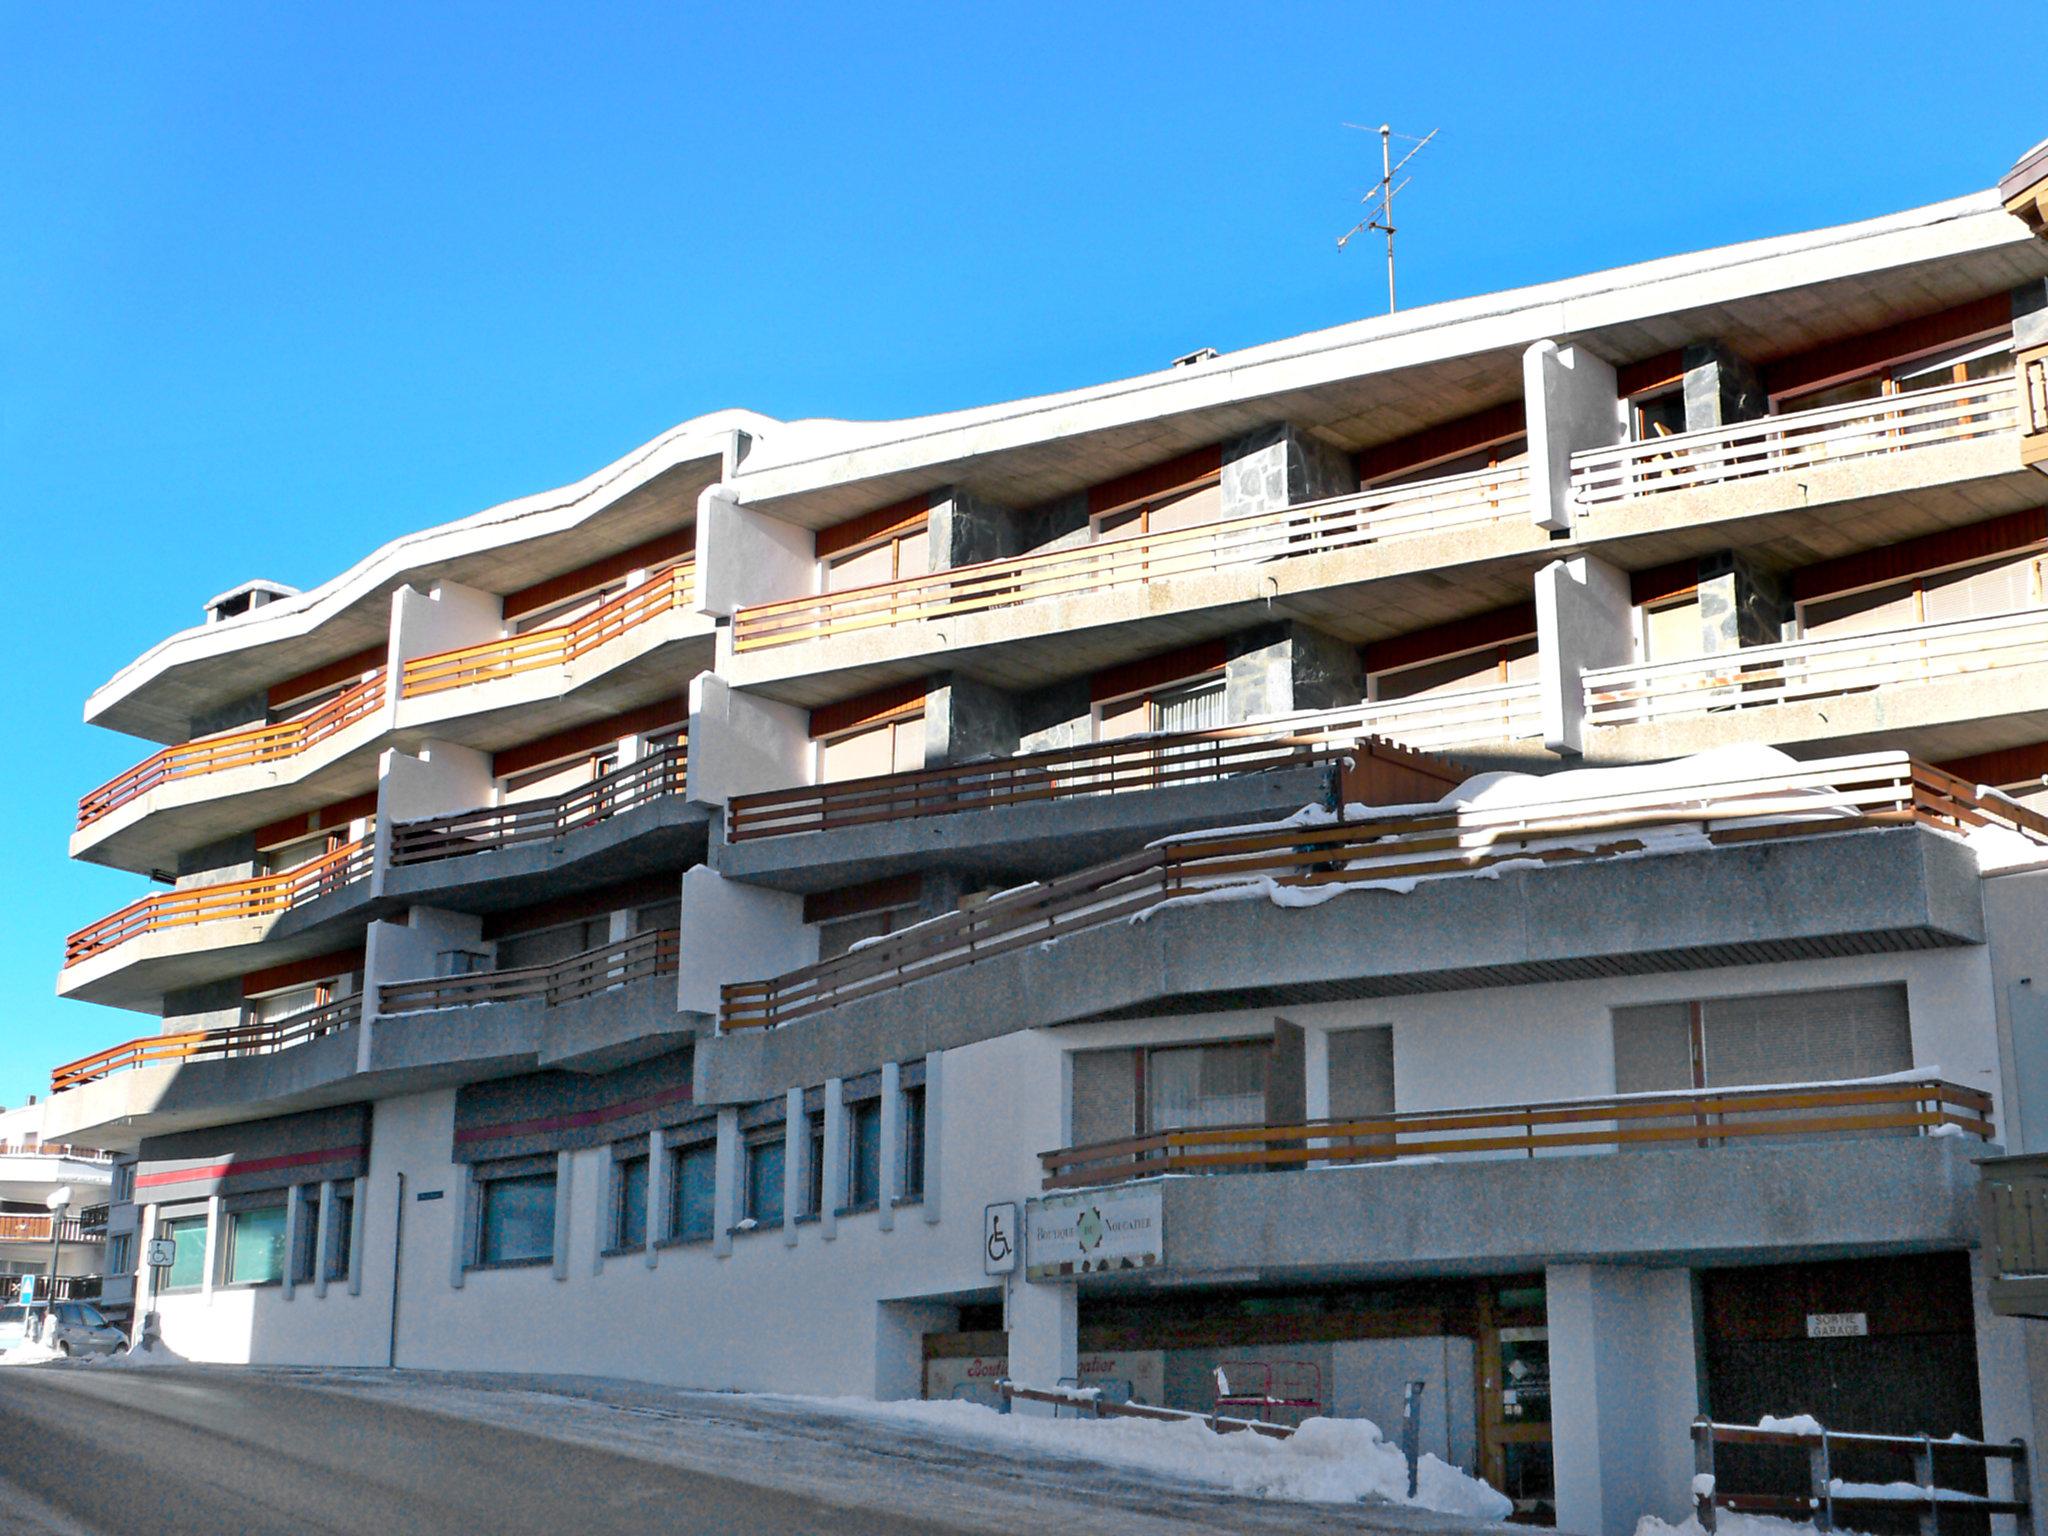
1583,608,2048,725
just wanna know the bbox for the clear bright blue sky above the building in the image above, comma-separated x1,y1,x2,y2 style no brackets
0,0,2048,1104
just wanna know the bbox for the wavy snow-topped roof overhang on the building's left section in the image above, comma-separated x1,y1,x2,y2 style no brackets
86,410,780,741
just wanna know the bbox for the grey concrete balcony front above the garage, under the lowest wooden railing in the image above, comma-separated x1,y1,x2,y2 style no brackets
1105,1135,1987,1290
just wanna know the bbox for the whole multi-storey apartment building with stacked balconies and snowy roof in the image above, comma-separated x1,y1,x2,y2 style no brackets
36,138,2048,1532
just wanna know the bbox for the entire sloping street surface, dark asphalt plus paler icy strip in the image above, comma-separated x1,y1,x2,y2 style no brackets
0,1366,1499,1536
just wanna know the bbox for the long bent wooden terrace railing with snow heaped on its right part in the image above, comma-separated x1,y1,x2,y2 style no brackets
721,752,2048,1030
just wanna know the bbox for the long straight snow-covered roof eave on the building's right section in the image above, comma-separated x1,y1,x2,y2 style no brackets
731,190,2048,528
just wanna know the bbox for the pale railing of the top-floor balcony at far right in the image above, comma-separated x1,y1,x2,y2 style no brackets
1571,375,2019,508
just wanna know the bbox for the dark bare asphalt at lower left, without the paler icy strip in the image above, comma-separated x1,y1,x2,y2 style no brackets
0,1368,963,1536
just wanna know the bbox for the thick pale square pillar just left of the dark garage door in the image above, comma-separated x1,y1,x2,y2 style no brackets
1544,1264,1700,1536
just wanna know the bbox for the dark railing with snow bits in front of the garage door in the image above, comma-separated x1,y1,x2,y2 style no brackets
1692,1419,2034,1536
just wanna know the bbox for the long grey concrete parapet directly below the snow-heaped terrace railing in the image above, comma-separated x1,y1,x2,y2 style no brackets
698,827,1985,1100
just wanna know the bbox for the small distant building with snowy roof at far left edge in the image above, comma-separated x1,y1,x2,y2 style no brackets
0,1102,112,1300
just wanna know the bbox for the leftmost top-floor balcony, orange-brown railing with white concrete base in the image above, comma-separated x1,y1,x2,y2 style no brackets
72,668,387,870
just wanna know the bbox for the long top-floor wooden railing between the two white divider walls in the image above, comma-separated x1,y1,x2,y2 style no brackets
733,465,1530,651
